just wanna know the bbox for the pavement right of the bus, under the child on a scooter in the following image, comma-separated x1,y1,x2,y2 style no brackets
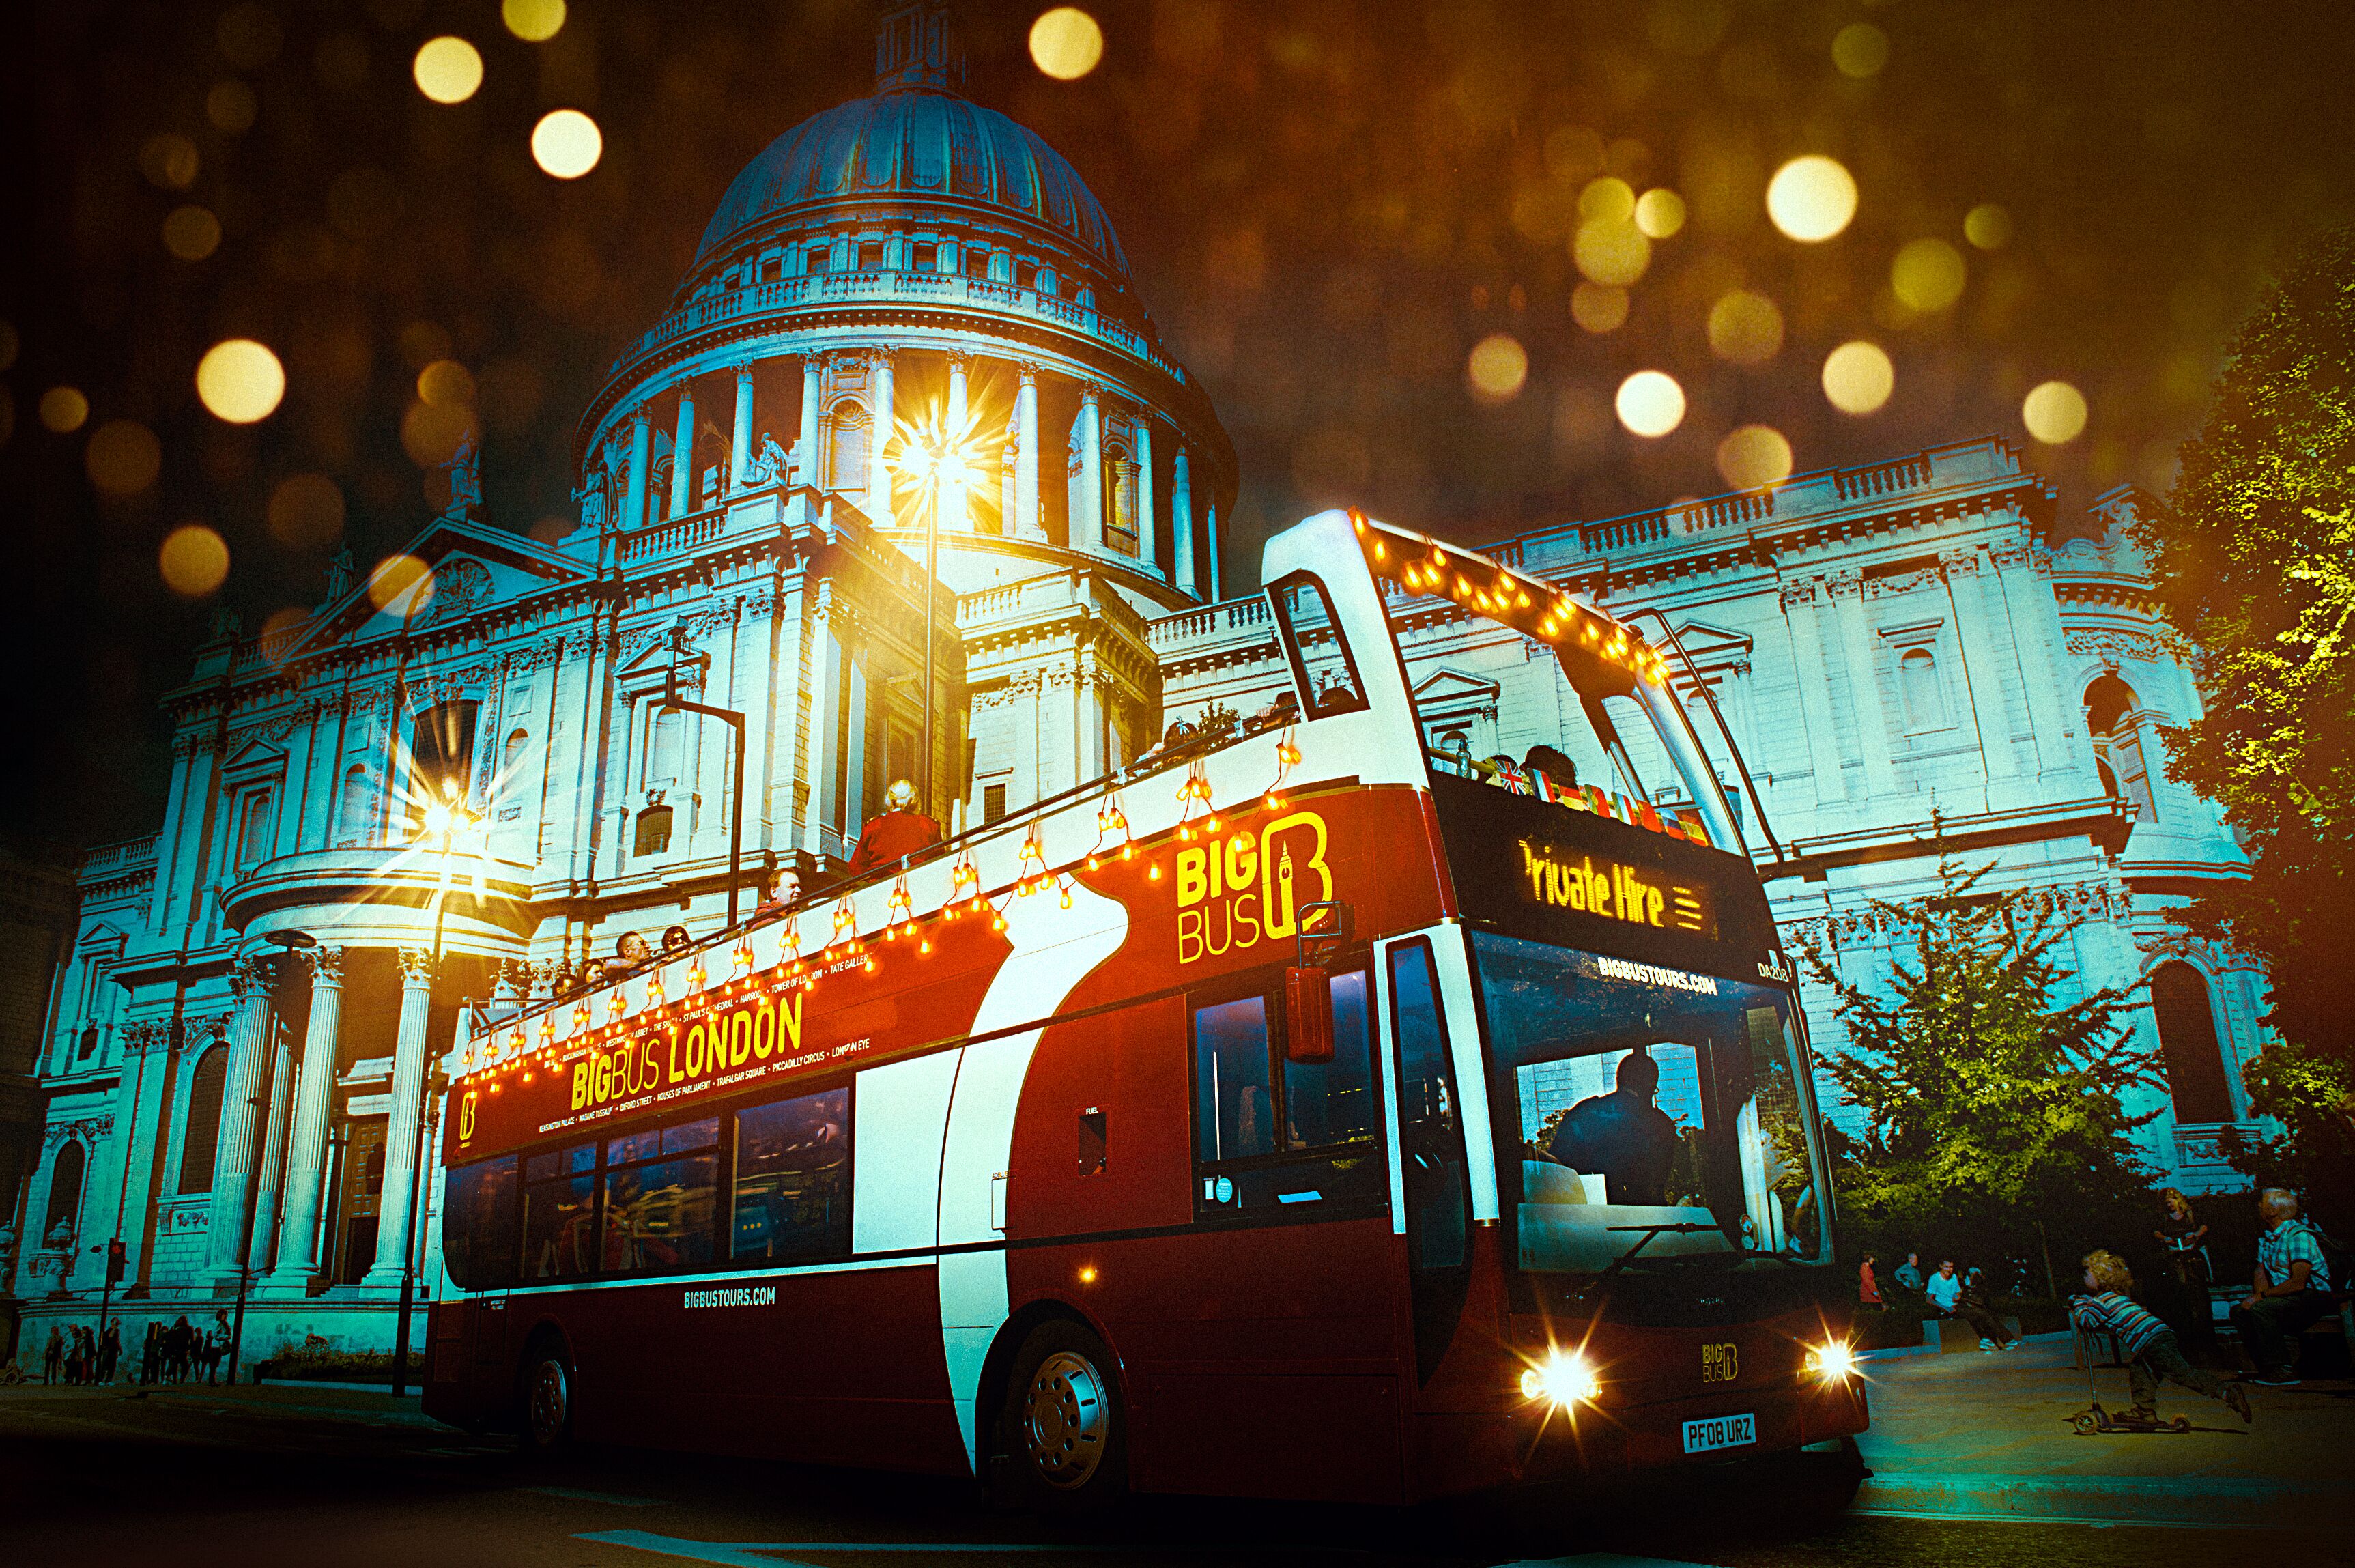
1856,1335,2355,1528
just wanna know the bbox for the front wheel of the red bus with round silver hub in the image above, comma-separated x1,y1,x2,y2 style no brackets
1003,1323,1128,1514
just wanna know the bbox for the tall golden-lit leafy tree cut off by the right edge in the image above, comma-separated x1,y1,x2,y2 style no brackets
2136,229,2355,1061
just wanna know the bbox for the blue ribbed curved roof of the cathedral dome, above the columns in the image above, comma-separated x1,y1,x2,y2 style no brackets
690,89,1128,285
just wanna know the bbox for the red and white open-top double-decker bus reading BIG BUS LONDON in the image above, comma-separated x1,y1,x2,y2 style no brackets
426,513,1865,1505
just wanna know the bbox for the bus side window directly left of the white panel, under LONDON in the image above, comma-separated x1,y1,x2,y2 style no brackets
728,1087,850,1262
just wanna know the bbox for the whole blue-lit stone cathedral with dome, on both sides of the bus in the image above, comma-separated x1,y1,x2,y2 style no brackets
0,7,2263,1358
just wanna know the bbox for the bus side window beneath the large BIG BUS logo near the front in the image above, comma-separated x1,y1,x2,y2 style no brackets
1192,970,1385,1217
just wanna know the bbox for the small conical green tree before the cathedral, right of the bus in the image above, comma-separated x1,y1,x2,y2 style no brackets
1806,838,2160,1288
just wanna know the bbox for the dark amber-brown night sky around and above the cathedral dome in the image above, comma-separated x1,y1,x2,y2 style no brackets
0,0,2355,843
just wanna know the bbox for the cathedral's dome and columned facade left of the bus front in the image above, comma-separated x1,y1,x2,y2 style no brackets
0,5,1236,1356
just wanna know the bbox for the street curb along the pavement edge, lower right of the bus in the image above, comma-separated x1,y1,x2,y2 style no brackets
1856,1467,2355,1530
